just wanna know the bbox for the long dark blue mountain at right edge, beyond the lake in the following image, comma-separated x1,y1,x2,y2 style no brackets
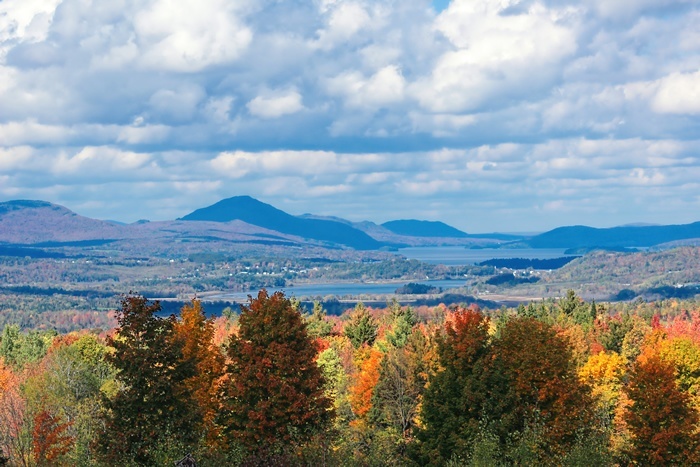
527,222,700,248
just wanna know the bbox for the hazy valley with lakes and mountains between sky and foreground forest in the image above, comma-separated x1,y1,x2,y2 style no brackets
0,196,700,331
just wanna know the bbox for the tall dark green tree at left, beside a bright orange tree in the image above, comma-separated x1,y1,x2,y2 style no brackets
98,295,197,465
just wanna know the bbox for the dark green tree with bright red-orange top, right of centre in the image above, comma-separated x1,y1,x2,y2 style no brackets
417,308,489,464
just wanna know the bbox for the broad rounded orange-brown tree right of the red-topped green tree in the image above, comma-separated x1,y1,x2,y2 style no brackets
484,317,592,459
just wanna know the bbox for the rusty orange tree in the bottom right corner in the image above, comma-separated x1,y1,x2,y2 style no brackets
624,353,700,465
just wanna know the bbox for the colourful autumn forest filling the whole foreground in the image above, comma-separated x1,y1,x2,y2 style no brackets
0,290,700,466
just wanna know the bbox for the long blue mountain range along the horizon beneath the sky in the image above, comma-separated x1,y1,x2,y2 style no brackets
0,196,700,253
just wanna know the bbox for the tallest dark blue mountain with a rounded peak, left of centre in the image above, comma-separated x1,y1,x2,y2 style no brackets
179,196,383,250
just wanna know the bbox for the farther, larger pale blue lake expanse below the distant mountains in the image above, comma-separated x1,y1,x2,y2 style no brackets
399,246,577,266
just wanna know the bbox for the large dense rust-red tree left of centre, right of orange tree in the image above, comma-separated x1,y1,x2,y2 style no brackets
219,289,332,456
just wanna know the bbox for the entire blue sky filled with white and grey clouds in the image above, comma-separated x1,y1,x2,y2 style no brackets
0,0,700,233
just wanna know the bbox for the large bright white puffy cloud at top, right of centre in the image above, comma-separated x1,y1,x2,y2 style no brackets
413,0,577,112
